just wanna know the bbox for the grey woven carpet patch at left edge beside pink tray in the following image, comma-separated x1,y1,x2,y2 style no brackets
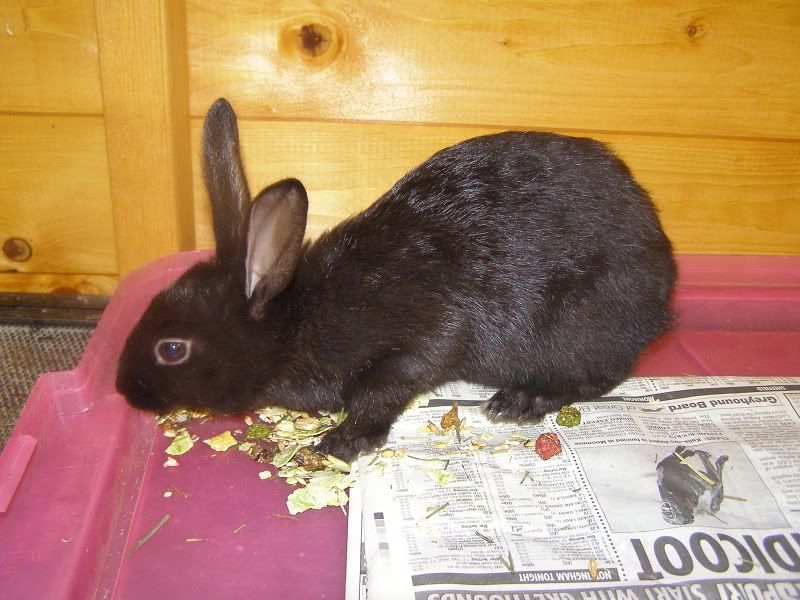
0,324,94,449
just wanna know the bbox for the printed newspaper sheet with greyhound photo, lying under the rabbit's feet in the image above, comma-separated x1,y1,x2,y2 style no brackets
347,377,800,600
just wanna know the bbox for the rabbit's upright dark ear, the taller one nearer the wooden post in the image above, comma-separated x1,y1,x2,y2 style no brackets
203,98,250,269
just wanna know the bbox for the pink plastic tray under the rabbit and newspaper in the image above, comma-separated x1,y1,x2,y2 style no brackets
0,252,800,600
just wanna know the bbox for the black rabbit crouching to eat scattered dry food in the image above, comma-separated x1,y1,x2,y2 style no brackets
117,100,675,459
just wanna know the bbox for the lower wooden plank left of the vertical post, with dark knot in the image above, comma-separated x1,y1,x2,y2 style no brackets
0,115,117,274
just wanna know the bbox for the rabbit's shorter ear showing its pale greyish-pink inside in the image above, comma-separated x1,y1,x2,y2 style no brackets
245,179,308,318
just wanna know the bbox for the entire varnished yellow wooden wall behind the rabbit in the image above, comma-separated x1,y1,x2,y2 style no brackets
0,0,800,293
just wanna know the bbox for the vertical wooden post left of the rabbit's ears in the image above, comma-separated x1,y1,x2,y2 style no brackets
95,0,194,275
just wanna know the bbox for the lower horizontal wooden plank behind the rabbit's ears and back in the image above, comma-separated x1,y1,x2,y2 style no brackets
192,119,800,254
